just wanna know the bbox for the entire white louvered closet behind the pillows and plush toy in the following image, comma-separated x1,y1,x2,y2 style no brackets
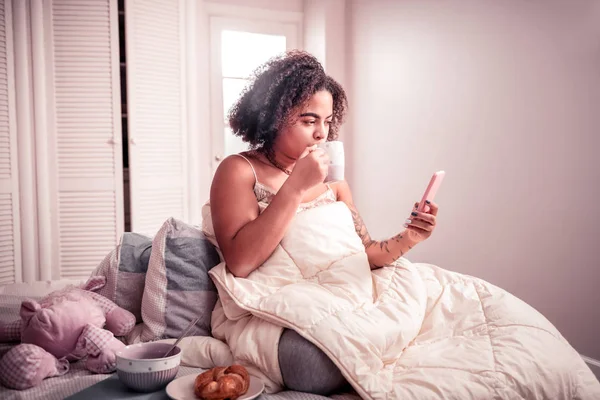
0,0,189,284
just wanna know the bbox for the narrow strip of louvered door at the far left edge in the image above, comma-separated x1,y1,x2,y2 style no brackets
0,0,21,285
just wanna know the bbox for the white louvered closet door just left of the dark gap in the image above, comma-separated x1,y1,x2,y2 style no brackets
46,0,123,277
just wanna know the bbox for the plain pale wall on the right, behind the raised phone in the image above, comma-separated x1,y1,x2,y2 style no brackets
347,0,600,359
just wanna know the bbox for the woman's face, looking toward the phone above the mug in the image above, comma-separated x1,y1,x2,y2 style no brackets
273,90,333,160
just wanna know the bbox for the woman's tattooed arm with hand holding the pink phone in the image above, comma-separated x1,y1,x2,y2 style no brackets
336,181,437,269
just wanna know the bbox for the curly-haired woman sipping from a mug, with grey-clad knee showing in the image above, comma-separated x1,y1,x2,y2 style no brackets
210,51,438,395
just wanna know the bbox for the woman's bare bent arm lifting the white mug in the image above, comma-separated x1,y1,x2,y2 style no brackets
210,151,328,278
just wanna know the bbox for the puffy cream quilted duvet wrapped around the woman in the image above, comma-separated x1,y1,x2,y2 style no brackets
205,202,600,400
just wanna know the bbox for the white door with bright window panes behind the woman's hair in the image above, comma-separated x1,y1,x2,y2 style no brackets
210,16,299,172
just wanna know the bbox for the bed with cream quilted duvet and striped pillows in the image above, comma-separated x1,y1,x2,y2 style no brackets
0,217,600,400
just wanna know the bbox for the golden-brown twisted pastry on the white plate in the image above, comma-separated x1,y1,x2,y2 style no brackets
194,364,250,400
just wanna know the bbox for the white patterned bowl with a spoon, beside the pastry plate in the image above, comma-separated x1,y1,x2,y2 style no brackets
116,342,181,392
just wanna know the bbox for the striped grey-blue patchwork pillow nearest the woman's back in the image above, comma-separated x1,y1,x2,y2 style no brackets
140,218,220,342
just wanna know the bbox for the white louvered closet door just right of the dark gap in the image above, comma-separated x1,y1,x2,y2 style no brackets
125,0,185,235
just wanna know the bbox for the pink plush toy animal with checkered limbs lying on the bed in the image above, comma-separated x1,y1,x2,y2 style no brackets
0,276,135,389
